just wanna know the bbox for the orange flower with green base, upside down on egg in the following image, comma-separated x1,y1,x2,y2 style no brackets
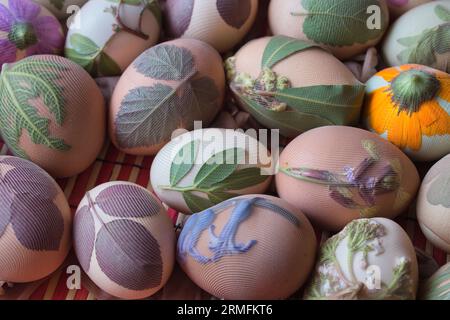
364,65,450,151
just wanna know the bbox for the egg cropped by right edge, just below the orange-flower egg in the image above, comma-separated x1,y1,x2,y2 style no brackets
417,154,450,253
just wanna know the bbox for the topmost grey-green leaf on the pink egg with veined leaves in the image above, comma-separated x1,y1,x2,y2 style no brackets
134,44,197,81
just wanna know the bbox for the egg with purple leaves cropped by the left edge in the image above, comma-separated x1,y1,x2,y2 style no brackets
0,156,72,287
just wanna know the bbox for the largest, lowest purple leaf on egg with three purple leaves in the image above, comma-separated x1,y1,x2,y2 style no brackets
95,220,163,290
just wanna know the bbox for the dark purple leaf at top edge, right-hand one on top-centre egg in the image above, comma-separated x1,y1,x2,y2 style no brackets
216,0,252,29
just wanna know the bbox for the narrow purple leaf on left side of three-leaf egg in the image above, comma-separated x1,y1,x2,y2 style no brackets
73,206,95,272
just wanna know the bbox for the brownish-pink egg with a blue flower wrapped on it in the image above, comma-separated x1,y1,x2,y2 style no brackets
177,195,316,300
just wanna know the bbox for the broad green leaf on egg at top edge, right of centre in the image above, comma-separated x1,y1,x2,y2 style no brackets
300,0,388,46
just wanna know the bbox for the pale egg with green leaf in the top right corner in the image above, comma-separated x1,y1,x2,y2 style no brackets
382,1,450,72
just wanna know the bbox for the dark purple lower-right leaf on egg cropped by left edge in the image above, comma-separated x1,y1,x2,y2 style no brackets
11,194,64,251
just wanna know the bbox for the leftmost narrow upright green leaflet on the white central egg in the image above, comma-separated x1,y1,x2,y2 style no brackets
170,140,200,186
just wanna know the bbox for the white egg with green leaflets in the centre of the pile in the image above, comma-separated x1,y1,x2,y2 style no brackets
150,129,272,214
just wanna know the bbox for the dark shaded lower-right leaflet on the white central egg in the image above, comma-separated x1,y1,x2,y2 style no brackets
215,167,270,190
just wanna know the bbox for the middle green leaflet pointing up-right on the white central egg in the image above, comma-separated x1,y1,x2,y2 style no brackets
194,148,245,188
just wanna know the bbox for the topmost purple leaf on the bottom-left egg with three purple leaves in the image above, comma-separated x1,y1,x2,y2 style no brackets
95,184,161,218
